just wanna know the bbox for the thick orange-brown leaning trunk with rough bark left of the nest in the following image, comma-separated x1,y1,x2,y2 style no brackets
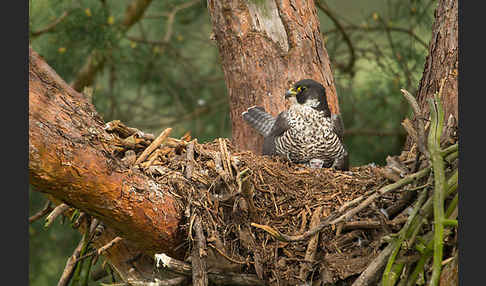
29,46,181,256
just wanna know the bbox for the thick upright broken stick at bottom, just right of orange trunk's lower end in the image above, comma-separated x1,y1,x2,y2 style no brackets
191,216,208,286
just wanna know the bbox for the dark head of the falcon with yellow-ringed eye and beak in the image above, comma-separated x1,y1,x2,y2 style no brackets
285,79,330,114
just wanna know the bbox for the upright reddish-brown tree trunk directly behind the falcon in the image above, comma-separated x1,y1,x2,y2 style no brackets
208,0,339,154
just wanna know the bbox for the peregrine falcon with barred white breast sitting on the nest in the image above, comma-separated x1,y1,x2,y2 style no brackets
242,79,349,170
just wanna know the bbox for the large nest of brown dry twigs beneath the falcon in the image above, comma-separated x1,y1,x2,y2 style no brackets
105,122,426,285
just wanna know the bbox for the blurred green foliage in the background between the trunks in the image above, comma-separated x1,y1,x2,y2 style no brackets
29,0,436,286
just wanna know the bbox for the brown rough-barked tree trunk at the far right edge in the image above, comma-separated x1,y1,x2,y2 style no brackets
406,0,459,149
